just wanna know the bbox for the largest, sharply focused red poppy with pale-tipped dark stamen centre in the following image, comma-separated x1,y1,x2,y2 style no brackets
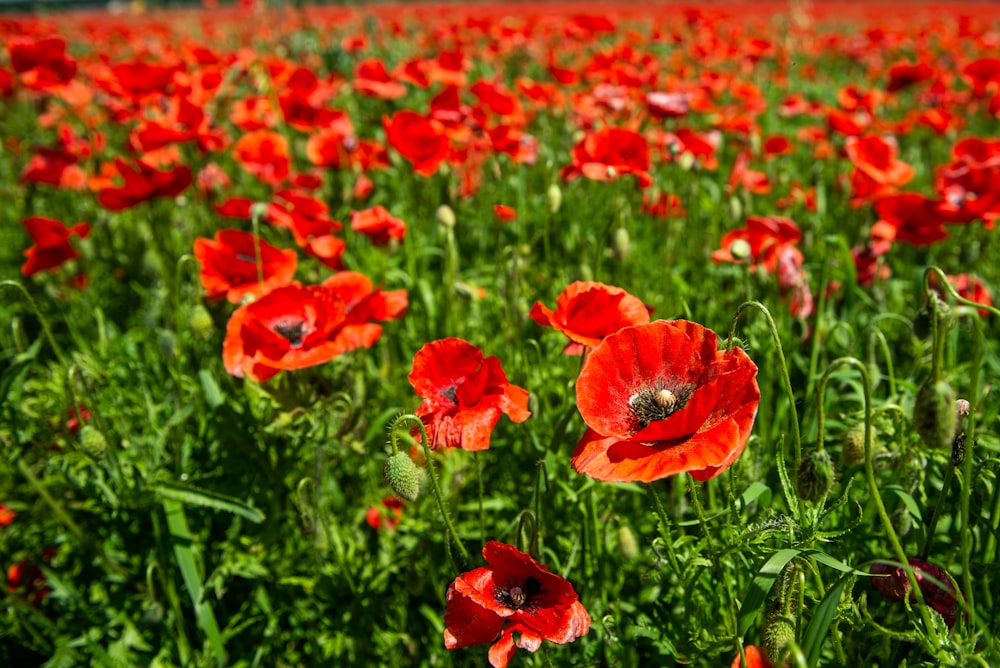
573,320,760,482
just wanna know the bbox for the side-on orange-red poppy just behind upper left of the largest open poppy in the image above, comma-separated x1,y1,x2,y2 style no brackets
528,281,649,355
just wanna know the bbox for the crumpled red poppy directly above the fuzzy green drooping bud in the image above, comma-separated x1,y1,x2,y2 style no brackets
408,338,531,450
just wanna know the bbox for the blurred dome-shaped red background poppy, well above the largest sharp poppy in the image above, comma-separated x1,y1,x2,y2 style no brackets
562,127,653,188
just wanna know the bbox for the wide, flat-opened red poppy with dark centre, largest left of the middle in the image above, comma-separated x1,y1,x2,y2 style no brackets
222,272,406,382
